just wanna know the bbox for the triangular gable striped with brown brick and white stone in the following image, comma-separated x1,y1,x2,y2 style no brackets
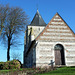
35,13,75,41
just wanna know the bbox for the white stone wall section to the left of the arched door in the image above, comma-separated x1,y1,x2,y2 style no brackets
36,42,54,67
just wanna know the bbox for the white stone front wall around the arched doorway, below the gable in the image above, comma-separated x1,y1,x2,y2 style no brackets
36,41,75,67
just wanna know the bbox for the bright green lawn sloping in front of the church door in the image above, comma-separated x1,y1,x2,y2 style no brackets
36,67,75,75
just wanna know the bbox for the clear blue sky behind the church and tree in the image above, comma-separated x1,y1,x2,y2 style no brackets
0,0,75,62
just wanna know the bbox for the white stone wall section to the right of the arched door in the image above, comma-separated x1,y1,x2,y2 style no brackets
65,42,75,66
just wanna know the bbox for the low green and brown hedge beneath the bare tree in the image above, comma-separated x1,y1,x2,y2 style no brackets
0,60,21,70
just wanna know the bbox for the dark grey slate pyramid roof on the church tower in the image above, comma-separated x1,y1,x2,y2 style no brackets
30,10,46,26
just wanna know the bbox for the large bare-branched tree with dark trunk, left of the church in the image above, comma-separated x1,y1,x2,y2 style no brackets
0,5,28,61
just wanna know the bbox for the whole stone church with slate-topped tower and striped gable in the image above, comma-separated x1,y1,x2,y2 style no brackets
24,10,75,68
